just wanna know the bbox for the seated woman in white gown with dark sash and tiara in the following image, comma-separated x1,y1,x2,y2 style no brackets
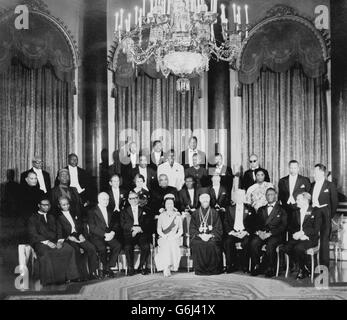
154,194,183,277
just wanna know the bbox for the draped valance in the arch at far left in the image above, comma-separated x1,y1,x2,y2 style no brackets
0,11,75,82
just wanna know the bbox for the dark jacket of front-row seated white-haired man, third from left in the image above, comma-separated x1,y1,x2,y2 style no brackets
88,206,121,239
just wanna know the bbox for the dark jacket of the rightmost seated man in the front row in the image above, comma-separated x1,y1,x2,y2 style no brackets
288,207,322,243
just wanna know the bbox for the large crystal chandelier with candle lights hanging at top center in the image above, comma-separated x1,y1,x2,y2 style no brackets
115,0,249,93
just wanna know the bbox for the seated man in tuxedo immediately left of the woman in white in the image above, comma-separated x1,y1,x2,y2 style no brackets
121,191,153,276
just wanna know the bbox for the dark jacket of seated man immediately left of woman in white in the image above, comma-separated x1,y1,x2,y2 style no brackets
120,206,154,238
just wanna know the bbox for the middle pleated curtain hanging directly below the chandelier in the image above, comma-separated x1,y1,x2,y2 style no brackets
115,75,202,165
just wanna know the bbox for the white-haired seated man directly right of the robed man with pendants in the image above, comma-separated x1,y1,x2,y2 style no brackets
223,189,255,273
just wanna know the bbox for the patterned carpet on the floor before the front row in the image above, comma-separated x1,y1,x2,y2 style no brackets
7,273,347,300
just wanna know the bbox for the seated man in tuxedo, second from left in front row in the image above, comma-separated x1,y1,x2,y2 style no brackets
57,197,99,280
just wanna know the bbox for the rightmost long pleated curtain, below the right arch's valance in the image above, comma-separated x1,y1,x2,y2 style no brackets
242,67,328,185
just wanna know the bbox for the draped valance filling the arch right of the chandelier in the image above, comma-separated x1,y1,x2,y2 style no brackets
239,15,327,84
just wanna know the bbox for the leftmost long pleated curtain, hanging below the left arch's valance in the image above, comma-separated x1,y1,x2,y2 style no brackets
0,62,74,211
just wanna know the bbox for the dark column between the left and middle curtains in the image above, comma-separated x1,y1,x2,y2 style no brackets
82,0,108,198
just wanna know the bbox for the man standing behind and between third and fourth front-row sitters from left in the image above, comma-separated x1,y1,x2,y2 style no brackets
107,174,127,214
